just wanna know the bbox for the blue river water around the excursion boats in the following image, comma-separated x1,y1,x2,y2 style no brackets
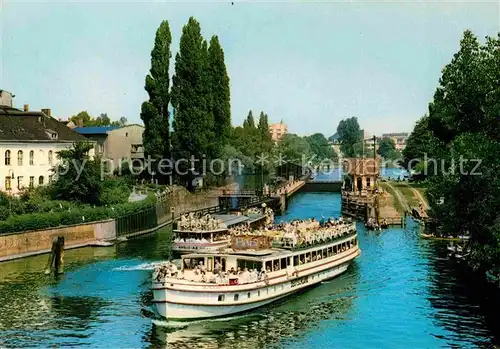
0,193,500,348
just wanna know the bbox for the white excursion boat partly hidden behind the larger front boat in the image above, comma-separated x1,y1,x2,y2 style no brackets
172,209,274,253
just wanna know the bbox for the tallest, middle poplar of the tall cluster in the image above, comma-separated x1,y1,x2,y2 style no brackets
171,17,215,170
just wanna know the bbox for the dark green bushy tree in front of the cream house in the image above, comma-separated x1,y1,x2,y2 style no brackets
52,142,102,205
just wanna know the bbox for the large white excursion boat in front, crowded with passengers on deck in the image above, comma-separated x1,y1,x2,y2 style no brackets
152,222,361,319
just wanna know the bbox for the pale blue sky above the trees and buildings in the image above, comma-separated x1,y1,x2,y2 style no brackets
0,0,500,136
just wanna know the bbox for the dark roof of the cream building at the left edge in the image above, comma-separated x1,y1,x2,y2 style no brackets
0,106,86,142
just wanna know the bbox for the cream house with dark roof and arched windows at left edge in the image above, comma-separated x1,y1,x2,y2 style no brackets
0,91,92,195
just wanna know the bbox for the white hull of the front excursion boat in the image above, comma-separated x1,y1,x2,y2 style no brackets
153,249,360,320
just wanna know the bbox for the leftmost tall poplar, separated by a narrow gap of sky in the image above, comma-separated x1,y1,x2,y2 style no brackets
141,21,172,159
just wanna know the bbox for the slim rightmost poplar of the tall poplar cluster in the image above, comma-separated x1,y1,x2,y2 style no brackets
208,35,231,154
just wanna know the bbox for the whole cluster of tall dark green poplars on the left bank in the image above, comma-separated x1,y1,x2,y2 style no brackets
141,17,231,179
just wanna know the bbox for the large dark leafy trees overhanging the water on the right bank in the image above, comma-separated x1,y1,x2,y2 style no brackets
403,31,500,272
